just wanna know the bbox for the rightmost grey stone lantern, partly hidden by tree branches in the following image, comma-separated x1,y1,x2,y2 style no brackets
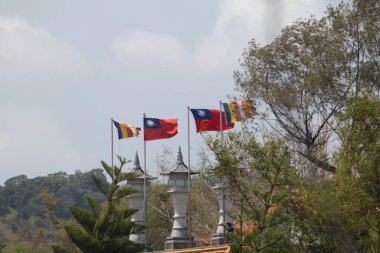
211,177,233,245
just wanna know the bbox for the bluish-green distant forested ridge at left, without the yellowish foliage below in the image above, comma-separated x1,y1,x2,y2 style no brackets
0,169,107,220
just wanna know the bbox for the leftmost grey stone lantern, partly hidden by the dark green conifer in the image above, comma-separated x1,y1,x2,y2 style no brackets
123,152,156,244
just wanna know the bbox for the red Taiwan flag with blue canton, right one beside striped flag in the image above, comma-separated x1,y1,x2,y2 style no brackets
190,109,234,133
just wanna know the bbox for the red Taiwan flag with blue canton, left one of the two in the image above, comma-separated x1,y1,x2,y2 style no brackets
144,118,178,141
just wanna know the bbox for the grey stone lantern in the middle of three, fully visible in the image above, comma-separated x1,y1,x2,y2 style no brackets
161,147,198,250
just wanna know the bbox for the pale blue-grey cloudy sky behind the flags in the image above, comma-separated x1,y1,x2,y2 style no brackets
0,0,337,184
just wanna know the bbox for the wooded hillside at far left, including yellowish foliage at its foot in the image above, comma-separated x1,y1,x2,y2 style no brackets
0,169,107,244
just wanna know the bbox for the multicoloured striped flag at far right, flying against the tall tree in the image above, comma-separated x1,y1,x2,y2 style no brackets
223,100,256,123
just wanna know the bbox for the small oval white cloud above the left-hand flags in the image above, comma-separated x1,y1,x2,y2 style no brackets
111,30,188,69
